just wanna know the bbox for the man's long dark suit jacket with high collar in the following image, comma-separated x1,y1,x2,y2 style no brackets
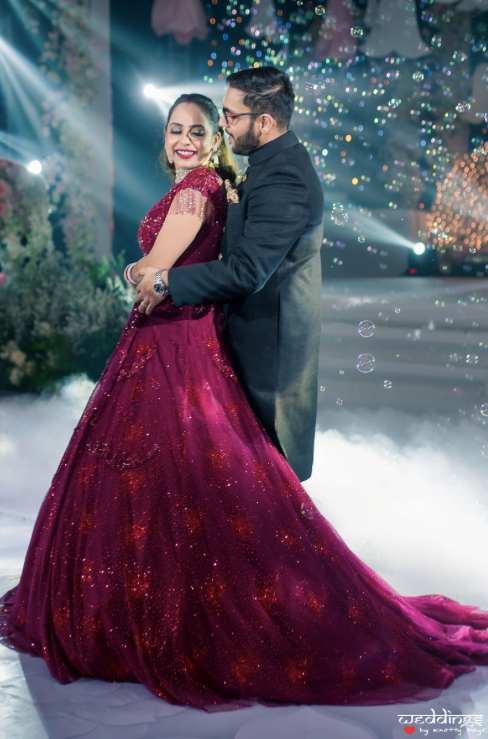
168,131,323,480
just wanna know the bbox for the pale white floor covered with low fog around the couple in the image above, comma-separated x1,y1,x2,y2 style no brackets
0,279,488,739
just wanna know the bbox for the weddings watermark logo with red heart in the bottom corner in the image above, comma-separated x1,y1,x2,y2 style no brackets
398,708,487,736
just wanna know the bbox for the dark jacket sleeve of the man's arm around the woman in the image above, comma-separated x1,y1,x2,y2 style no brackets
168,165,309,306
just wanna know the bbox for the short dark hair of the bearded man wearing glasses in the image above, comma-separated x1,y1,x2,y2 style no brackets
227,67,295,128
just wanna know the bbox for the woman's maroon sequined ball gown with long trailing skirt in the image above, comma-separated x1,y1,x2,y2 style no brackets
0,169,488,711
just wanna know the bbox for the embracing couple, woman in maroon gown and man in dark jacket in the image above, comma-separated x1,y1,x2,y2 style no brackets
0,68,488,711
